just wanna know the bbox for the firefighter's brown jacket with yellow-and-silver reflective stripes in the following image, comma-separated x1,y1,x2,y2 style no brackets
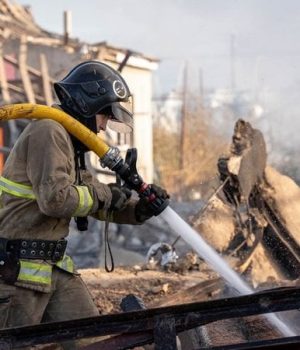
0,119,137,292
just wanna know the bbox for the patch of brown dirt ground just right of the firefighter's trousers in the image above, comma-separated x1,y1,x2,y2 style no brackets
79,266,215,314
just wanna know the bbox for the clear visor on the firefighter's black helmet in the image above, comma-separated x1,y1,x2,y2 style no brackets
107,98,133,133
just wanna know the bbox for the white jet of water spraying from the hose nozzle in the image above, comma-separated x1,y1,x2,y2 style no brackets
160,207,296,337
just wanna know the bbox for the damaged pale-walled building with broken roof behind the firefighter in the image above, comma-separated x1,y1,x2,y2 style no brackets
0,0,158,182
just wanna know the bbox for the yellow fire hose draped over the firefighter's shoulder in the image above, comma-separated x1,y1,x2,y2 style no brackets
0,103,109,158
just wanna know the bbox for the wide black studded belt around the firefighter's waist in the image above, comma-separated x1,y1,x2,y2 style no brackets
6,239,67,262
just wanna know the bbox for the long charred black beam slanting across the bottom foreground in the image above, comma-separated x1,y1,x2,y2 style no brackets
0,287,300,349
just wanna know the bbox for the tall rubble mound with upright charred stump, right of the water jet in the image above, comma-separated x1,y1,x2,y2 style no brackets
192,120,300,287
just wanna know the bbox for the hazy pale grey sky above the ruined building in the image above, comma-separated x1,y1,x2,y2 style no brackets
18,0,300,95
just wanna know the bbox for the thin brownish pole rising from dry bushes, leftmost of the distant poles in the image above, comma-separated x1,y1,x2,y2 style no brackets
179,63,188,169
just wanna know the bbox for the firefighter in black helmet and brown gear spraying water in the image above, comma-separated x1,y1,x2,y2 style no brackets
0,61,168,349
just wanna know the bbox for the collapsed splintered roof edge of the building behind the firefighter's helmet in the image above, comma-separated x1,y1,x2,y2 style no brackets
0,0,158,70
